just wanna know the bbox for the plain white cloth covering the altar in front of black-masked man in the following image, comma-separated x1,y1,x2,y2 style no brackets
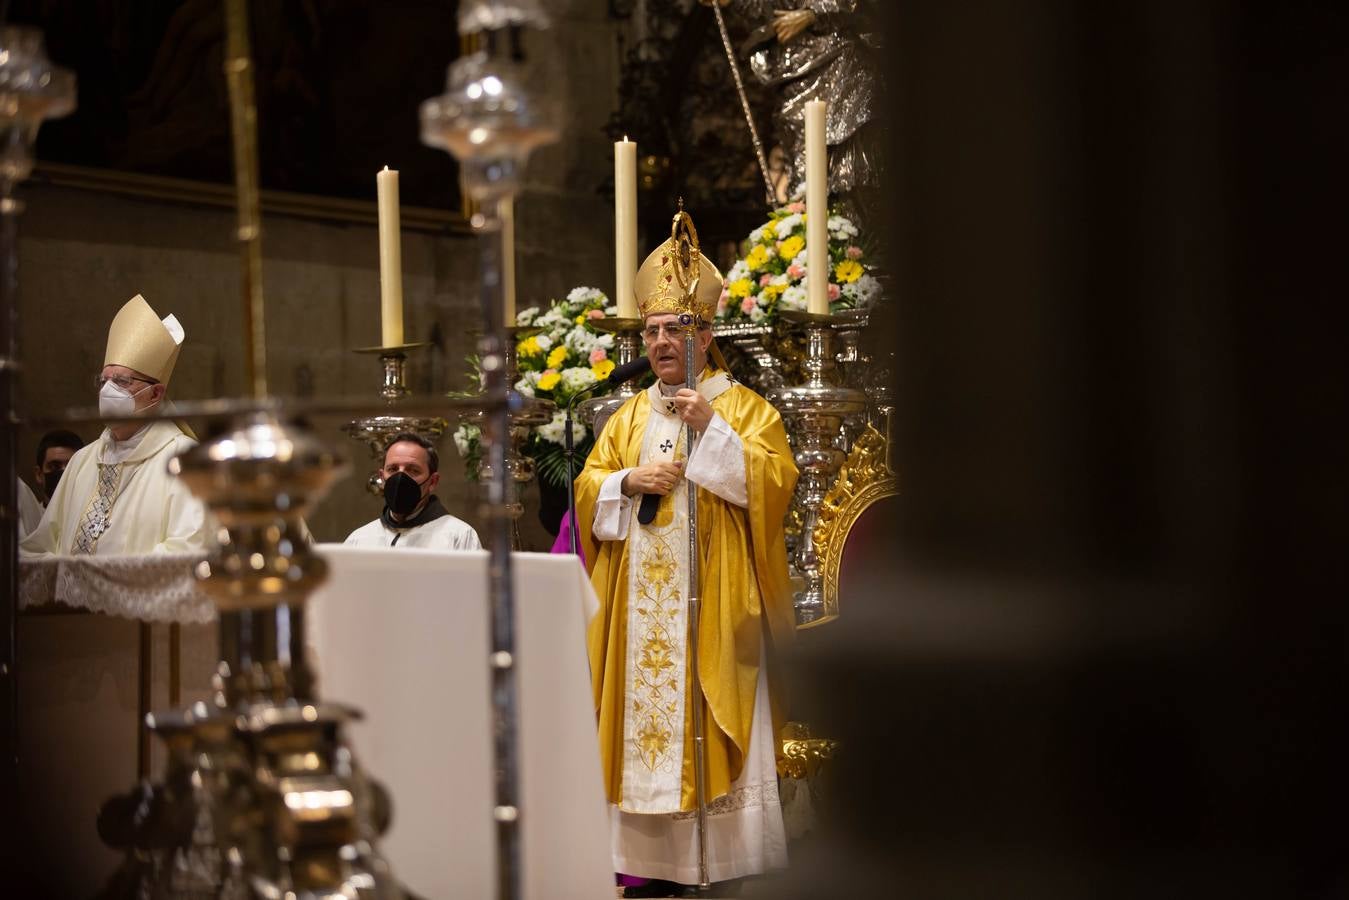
308,544,614,900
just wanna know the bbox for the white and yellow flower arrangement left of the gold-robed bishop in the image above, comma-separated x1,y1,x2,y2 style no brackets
455,287,618,487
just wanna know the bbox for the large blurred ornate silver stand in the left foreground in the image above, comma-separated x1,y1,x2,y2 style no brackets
170,412,399,897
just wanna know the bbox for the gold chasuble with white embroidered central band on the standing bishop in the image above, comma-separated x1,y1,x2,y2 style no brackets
576,370,796,814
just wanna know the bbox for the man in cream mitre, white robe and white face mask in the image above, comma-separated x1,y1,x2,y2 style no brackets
20,294,206,556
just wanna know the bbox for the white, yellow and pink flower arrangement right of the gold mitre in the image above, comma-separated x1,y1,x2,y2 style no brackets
716,202,881,324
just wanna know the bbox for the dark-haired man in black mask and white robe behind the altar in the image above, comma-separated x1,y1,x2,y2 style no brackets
345,432,483,551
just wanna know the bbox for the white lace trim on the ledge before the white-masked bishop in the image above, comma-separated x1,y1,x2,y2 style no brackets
19,553,216,625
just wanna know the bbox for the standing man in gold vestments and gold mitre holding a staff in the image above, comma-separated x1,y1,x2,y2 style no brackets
576,218,796,884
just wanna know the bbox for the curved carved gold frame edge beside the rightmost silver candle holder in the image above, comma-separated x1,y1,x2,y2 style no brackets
800,425,900,629
